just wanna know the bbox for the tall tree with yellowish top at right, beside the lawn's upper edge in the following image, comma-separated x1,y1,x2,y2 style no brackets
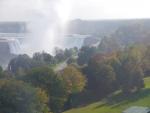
118,47,144,94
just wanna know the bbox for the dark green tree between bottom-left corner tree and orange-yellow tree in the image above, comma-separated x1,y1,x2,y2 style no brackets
23,67,67,113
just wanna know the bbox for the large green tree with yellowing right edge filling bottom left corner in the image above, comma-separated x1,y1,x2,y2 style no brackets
0,80,49,113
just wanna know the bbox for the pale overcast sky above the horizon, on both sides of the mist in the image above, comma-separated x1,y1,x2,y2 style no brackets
0,0,150,21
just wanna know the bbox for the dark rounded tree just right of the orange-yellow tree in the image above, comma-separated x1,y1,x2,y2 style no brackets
86,59,116,98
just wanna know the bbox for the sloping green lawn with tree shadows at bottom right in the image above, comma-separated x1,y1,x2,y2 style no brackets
64,77,150,113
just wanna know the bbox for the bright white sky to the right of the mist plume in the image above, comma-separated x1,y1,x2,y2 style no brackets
70,0,150,19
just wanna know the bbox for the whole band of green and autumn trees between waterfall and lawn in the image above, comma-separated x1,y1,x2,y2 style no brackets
0,44,150,113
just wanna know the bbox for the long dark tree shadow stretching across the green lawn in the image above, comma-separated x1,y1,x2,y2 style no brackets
95,88,150,109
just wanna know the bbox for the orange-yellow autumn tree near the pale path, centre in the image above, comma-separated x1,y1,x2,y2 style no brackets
60,65,86,108
